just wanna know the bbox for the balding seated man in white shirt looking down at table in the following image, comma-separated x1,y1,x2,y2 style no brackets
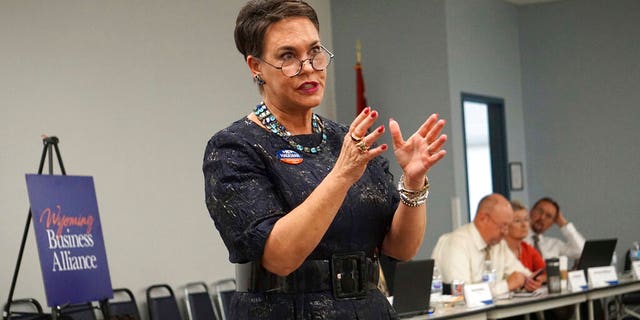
432,194,541,296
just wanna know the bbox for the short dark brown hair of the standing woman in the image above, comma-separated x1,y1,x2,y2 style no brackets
234,0,320,59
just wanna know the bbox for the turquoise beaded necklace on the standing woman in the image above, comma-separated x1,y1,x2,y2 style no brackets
253,101,327,154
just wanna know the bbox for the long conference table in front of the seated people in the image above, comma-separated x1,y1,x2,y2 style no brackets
410,277,640,320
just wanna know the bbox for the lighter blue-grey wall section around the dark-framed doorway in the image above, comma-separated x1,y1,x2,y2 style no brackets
445,0,528,218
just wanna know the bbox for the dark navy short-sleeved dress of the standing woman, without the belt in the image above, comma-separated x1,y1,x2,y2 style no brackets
203,114,399,319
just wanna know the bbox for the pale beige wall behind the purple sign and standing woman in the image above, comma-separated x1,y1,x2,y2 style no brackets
0,0,334,313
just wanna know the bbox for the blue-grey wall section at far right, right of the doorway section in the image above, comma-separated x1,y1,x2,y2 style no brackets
519,0,640,267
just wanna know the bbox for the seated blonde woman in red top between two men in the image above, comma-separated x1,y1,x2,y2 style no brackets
506,201,546,276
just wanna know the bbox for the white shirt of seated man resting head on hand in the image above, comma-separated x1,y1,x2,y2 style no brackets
524,222,585,259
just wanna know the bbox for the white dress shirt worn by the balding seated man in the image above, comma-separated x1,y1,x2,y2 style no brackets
431,223,531,295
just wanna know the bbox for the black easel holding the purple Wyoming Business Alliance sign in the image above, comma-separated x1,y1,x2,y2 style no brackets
2,136,110,320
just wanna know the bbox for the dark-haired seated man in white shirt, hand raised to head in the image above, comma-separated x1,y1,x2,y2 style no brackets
525,197,585,259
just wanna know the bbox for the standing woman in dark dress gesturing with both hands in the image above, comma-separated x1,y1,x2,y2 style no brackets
203,0,446,319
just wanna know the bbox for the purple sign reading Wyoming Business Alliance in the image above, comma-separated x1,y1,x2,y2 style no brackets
26,174,113,307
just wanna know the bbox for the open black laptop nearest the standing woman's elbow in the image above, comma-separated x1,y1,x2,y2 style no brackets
393,259,434,318
